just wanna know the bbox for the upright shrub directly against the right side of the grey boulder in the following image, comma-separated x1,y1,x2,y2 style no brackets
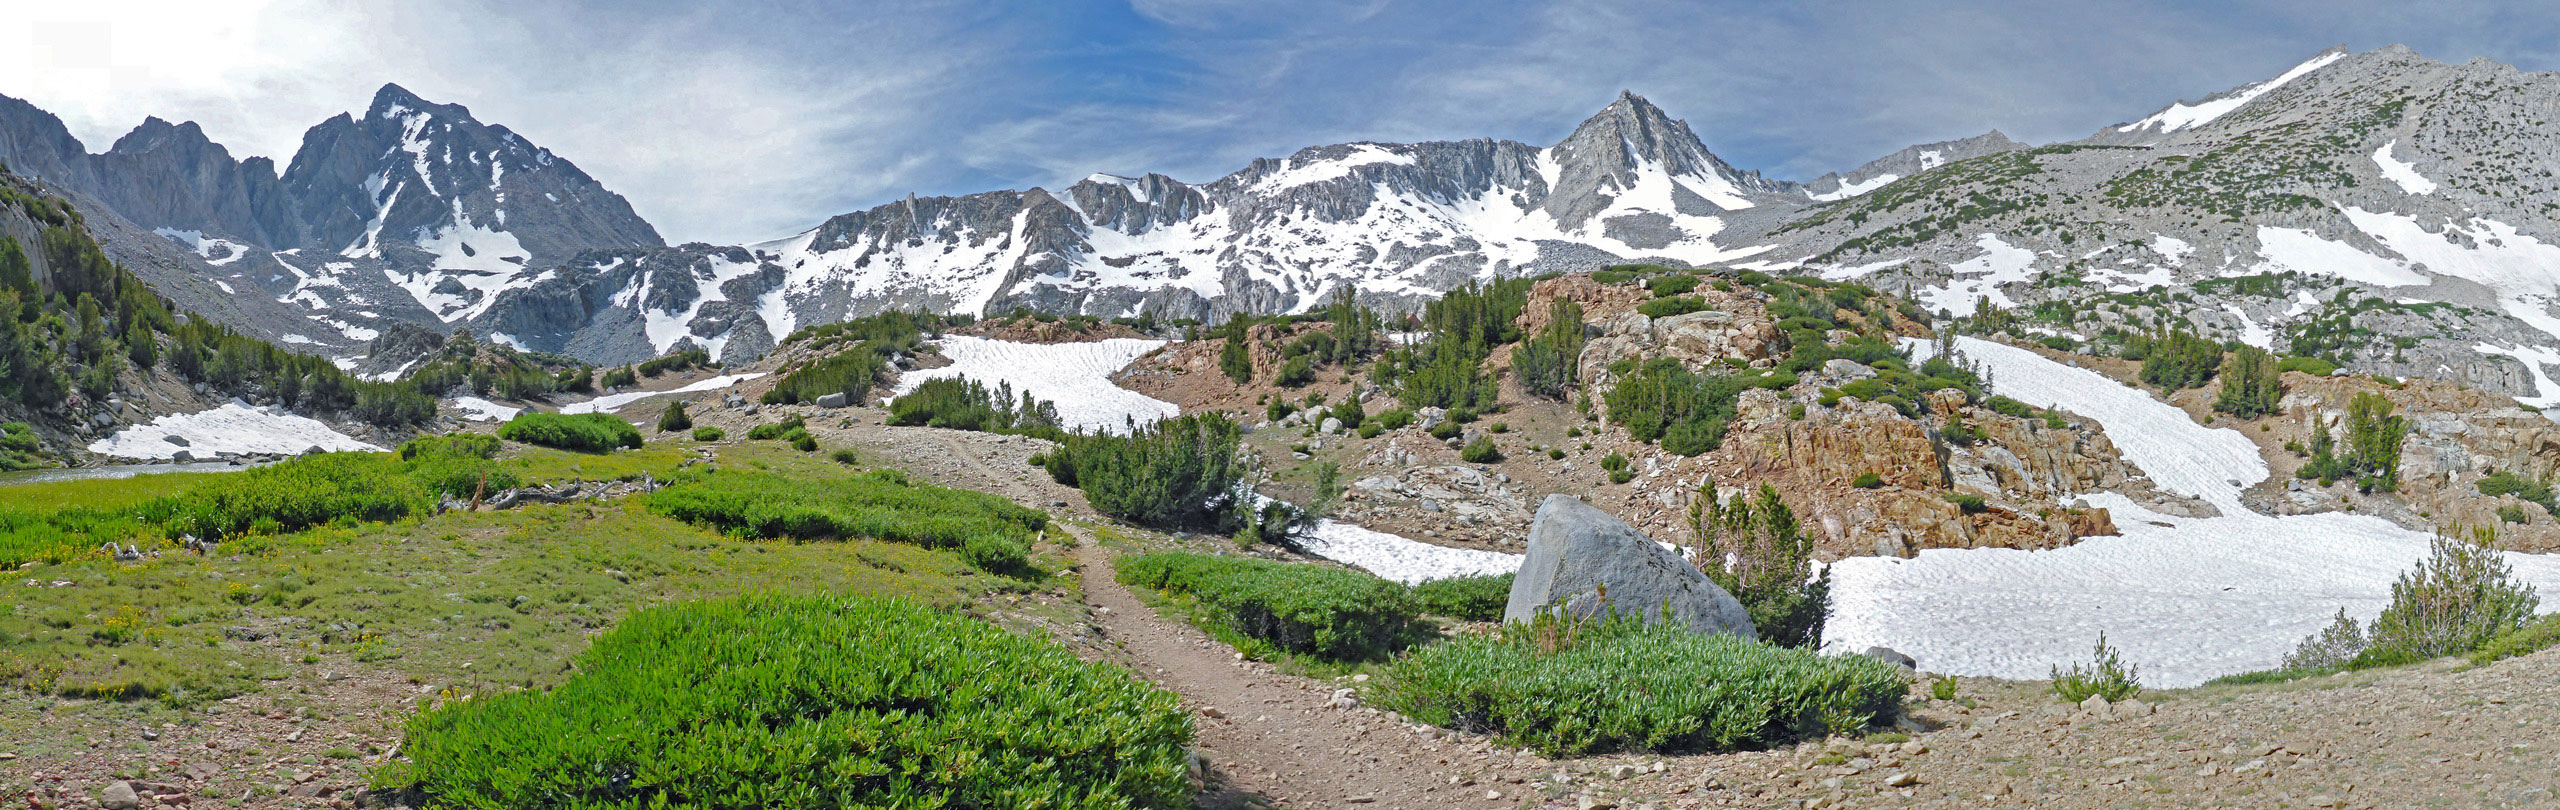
1690,482,1830,649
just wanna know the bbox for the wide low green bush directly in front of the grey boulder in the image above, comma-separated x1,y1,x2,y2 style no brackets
1375,618,1907,756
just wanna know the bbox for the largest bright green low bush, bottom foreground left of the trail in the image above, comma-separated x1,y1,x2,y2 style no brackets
399,595,1190,810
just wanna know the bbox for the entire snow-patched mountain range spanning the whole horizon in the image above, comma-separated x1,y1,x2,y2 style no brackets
0,46,2560,405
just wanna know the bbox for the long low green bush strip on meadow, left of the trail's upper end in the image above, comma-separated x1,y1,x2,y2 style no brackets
648,469,1050,574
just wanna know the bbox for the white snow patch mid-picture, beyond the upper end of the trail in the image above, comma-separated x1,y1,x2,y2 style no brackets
896,336,1183,433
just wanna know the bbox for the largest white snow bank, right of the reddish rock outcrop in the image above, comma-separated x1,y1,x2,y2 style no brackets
1823,338,2560,687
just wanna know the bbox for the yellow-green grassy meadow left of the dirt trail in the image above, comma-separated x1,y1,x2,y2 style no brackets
0,502,993,705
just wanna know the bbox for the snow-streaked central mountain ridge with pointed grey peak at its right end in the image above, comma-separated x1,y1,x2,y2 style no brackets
476,95,1805,359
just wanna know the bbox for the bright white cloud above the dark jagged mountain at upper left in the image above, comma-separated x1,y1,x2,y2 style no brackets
0,0,1006,241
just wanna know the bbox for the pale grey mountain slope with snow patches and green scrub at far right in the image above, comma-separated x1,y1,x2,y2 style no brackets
1736,46,2560,402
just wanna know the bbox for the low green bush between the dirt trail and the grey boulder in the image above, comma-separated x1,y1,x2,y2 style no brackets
1119,551,1418,661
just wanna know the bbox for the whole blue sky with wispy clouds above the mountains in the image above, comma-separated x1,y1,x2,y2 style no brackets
0,0,2560,241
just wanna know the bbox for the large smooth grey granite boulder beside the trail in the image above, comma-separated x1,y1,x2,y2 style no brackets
1503,495,1759,638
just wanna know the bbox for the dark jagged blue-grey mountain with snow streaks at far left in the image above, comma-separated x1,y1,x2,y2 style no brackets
0,85,663,359
